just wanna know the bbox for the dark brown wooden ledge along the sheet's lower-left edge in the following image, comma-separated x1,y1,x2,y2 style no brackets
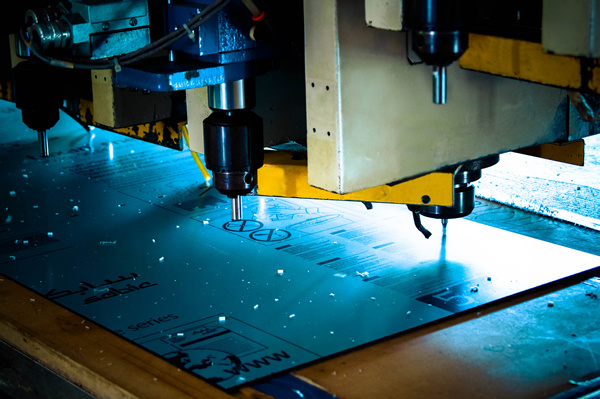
0,275,239,399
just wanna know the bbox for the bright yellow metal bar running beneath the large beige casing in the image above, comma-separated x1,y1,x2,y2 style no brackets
258,151,454,206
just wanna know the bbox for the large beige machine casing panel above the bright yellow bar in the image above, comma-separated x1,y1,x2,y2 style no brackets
304,0,568,193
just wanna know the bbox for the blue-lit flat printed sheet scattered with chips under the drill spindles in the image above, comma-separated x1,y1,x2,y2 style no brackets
0,104,600,388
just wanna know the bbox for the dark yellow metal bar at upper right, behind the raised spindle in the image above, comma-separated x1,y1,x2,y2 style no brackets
459,33,600,93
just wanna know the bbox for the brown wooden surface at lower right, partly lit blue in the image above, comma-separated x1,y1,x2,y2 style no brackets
295,280,600,399
